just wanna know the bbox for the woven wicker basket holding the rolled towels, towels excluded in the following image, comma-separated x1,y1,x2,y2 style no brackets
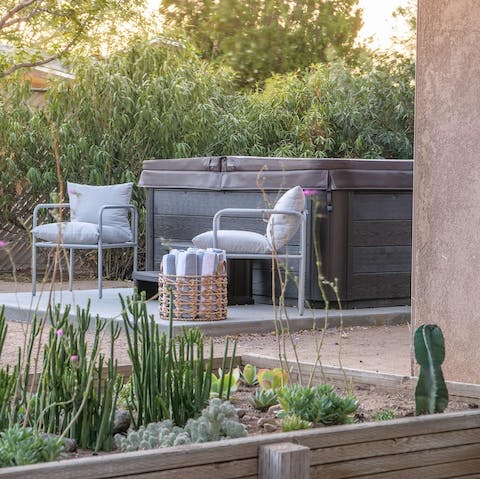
158,264,227,321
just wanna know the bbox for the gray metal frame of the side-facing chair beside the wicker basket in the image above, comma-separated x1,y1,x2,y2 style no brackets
213,208,307,316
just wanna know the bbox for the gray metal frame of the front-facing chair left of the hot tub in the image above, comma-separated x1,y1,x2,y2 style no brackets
32,203,138,298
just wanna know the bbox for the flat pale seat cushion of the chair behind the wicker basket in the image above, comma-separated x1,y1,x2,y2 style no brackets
192,230,272,254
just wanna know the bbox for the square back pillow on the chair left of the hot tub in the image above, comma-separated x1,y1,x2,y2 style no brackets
67,182,133,229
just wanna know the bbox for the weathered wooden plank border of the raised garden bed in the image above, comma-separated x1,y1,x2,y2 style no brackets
1,355,480,479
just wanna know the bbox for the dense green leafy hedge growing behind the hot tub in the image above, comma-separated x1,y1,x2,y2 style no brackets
0,44,414,274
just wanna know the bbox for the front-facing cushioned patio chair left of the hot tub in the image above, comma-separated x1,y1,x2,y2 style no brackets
32,182,138,298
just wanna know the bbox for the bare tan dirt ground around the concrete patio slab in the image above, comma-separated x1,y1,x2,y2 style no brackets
0,280,411,375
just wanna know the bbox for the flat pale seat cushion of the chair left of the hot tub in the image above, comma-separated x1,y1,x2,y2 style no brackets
32,221,132,245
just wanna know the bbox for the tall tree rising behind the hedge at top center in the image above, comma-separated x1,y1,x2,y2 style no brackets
160,0,362,84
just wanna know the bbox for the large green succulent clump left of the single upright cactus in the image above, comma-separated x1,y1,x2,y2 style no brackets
278,384,358,425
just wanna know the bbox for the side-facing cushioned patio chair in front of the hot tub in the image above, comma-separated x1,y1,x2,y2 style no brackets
192,186,307,315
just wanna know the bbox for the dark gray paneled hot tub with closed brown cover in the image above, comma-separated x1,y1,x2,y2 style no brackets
139,156,413,306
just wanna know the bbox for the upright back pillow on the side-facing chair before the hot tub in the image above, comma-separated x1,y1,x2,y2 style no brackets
267,186,305,250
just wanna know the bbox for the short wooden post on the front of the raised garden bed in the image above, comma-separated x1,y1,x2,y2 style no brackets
258,442,310,479
